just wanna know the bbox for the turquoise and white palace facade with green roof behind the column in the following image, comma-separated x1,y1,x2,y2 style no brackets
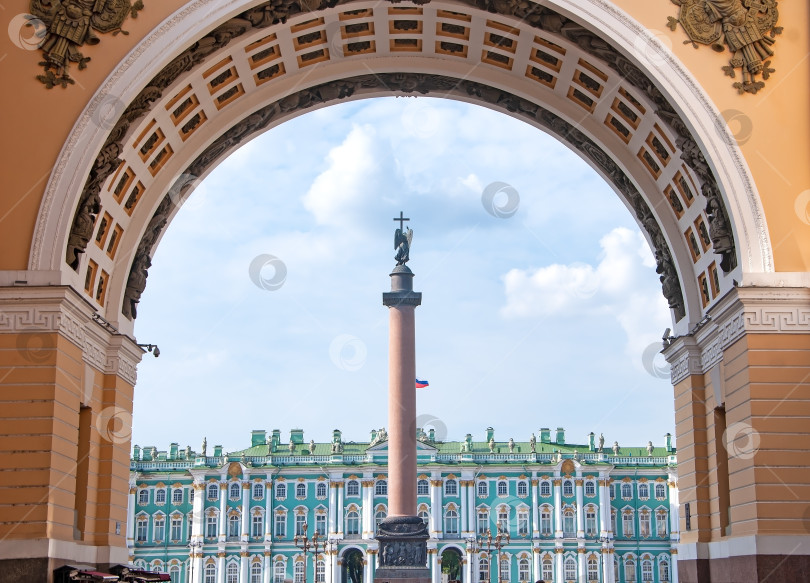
126,428,679,583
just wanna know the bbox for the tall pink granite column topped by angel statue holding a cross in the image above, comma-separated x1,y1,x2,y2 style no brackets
374,212,430,583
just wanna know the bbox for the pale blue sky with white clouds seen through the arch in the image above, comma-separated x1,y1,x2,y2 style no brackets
133,97,674,451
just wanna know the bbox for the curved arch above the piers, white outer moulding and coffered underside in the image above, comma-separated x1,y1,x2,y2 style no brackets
31,0,772,332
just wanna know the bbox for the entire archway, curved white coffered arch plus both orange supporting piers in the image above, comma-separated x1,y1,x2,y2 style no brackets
0,0,810,580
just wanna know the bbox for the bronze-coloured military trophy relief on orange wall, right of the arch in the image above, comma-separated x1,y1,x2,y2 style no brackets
667,0,782,94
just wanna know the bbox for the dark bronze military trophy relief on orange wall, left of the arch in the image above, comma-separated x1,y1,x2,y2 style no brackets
29,0,143,89
